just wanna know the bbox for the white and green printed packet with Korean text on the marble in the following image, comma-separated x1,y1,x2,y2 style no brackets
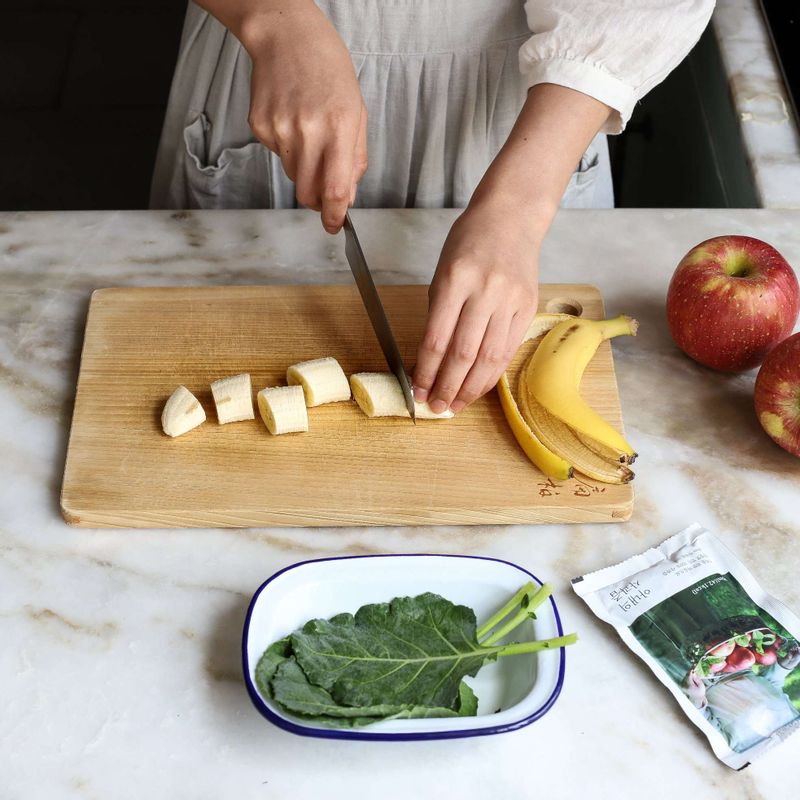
572,523,800,769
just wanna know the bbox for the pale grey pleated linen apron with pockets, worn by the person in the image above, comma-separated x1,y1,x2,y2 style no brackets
150,0,613,208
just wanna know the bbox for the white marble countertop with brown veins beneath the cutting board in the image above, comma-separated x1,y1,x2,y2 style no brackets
0,210,800,800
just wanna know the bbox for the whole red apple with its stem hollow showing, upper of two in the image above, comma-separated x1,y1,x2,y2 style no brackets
667,236,800,372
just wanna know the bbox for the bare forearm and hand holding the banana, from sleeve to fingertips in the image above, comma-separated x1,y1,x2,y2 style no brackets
414,83,610,412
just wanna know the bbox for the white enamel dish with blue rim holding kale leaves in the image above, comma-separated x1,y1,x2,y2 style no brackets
242,555,566,740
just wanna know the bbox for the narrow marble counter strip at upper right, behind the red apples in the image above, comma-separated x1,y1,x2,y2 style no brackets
712,0,800,208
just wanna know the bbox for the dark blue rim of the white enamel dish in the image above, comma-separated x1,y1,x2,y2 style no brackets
242,553,567,742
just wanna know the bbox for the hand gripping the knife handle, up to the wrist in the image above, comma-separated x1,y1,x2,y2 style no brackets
238,0,367,233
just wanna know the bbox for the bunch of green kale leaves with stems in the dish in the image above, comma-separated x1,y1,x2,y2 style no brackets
255,583,576,727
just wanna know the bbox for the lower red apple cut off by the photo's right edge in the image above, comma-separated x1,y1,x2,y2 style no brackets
755,333,800,456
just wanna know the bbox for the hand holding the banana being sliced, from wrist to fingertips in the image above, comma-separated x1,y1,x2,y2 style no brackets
414,206,541,413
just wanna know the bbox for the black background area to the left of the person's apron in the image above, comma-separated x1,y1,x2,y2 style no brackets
0,0,186,210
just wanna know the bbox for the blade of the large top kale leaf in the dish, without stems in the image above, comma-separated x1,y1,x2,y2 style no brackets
291,593,488,710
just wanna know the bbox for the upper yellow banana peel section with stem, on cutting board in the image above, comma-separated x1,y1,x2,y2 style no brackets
523,316,638,460
